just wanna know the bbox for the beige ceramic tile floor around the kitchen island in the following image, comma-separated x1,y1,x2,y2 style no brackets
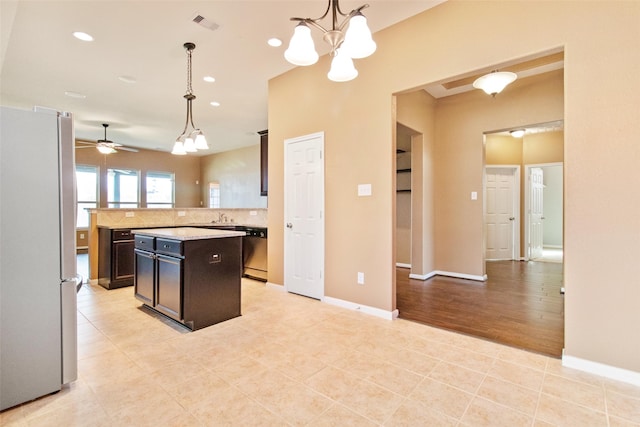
0,279,640,427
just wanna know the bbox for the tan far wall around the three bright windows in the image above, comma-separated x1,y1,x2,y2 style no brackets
76,148,201,208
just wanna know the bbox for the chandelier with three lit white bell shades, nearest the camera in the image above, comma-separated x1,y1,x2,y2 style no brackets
284,0,376,82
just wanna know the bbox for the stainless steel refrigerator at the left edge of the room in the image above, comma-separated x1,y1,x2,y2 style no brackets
0,107,81,410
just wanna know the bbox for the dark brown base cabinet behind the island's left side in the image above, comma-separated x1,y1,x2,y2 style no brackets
98,228,134,289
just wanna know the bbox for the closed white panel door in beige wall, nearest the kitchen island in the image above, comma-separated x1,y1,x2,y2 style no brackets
284,133,324,299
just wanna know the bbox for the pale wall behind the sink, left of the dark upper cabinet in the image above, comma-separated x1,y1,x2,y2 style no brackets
200,144,267,208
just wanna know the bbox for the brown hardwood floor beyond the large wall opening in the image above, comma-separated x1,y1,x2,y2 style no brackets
396,261,564,357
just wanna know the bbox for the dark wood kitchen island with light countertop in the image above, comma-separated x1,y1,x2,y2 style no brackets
132,227,245,331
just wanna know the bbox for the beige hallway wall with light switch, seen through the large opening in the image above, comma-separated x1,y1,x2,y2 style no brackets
434,70,564,277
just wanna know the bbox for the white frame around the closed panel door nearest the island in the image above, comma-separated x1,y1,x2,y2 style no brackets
283,132,325,300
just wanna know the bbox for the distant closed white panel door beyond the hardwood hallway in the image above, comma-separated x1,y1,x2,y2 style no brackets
485,167,515,260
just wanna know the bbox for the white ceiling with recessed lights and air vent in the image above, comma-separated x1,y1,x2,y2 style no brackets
0,0,444,155
